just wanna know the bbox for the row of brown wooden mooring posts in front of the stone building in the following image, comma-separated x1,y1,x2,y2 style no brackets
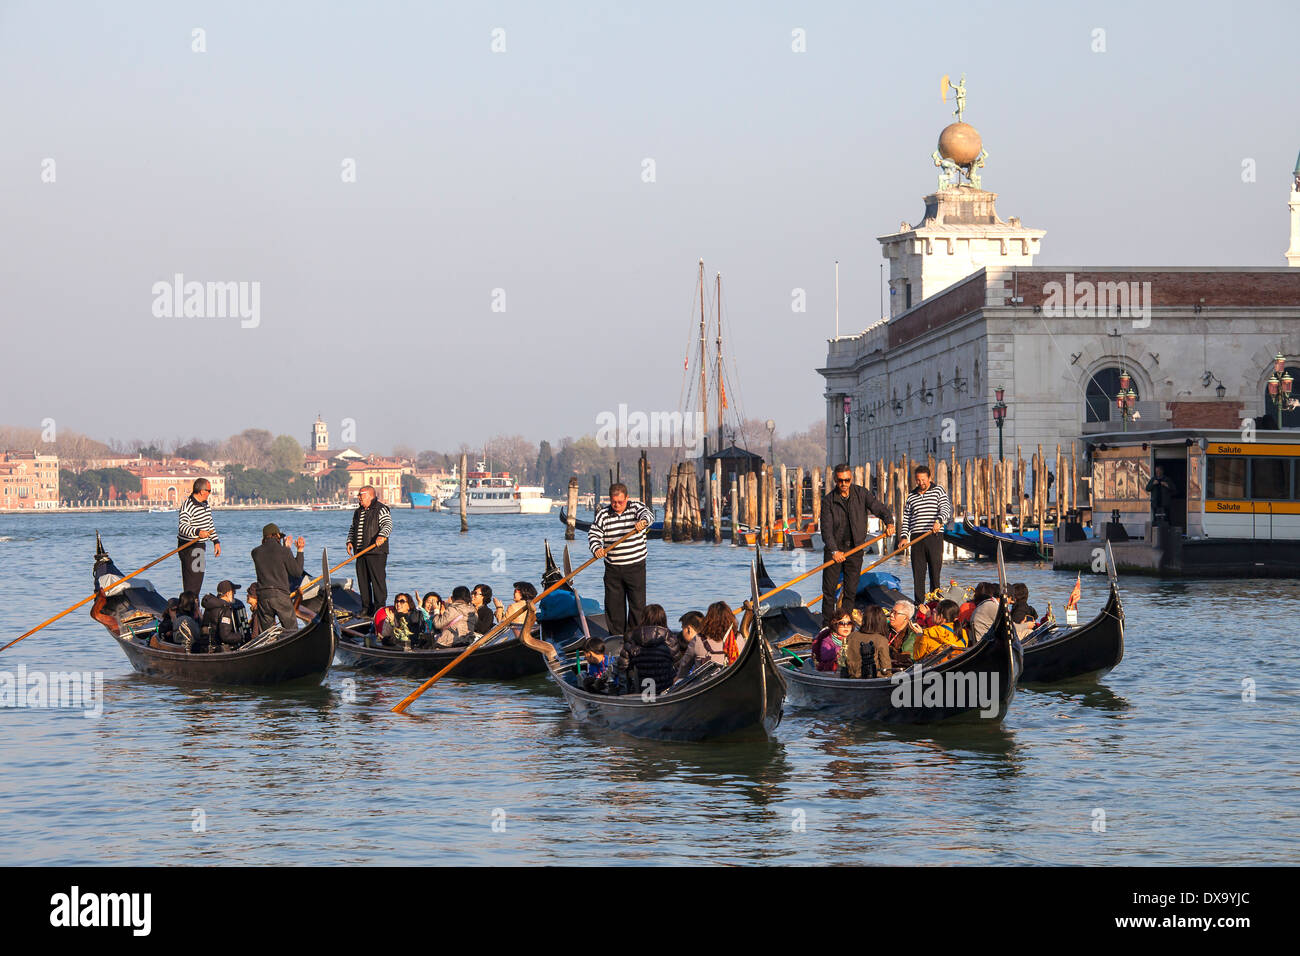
553,442,1087,545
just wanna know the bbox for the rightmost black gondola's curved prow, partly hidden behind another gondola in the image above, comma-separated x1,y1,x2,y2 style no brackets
1021,541,1125,684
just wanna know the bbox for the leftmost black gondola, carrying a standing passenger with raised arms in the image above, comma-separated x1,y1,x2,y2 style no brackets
91,533,335,685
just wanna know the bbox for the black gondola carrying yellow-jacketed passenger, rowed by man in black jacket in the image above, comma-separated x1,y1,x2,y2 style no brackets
781,541,1023,723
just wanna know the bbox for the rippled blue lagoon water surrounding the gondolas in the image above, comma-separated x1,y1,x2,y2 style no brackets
0,511,1300,864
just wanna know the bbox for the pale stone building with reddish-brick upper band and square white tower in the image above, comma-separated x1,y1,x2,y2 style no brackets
818,120,1300,478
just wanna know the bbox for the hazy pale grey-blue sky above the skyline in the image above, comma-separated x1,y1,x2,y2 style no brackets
0,0,1300,451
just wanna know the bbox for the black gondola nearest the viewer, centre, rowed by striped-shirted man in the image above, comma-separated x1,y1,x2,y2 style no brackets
514,566,785,741
